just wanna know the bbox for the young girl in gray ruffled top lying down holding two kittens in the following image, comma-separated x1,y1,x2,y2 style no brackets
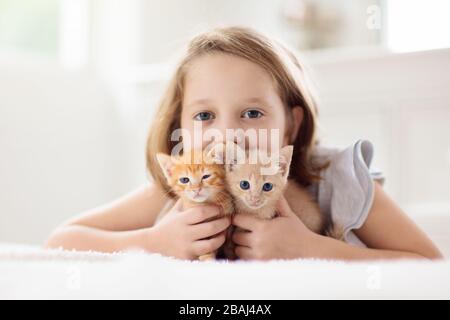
47,27,441,260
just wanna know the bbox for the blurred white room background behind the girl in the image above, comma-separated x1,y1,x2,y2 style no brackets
0,0,450,248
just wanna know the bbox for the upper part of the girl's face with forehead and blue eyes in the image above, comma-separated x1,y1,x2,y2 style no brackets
181,53,302,148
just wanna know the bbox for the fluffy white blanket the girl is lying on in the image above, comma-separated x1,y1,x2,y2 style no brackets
0,245,450,299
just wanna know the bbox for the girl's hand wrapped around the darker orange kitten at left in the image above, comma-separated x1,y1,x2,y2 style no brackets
148,200,231,260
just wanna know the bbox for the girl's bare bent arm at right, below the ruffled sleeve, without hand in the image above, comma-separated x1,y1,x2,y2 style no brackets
318,182,442,259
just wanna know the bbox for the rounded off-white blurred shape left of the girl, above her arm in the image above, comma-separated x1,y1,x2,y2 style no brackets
0,61,145,242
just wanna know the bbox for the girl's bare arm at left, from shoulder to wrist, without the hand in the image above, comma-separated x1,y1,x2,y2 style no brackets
46,185,168,252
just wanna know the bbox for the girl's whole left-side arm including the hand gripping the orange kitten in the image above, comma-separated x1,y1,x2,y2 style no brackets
47,185,230,259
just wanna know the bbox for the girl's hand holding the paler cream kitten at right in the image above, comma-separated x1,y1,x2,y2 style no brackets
233,197,317,260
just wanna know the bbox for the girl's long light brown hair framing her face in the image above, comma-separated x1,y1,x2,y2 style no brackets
146,27,320,194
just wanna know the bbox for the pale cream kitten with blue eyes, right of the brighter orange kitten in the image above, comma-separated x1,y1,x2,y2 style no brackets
226,146,327,233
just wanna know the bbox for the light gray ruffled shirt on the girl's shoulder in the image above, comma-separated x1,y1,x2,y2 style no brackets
309,140,384,246
